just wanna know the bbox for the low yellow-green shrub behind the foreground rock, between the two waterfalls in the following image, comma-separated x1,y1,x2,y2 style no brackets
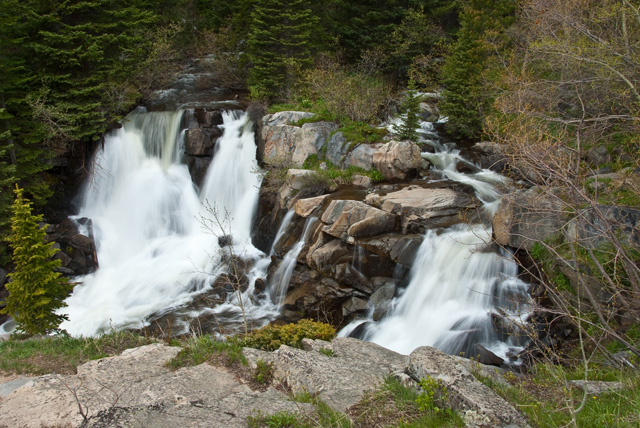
241,319,336,351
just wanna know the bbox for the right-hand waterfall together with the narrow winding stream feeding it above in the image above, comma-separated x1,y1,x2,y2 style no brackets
340,118,529,357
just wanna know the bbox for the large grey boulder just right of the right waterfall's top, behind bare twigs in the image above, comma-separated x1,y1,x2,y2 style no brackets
492,187,568,251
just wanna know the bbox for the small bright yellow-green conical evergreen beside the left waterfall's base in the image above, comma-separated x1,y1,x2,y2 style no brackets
2,186,73,334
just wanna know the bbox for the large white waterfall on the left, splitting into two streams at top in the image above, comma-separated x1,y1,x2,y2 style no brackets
61,111,272,336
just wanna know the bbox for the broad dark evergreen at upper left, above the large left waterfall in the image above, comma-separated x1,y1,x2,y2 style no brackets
28,0,155,140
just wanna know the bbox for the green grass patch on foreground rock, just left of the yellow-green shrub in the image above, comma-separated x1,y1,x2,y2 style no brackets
168,335,247,368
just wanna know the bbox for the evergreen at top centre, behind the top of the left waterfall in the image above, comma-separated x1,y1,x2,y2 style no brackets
248,0,317,101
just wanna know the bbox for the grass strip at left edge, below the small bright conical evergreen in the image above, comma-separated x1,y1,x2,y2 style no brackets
0,331,153,375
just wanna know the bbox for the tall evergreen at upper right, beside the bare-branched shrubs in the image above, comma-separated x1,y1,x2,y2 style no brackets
440,0,515,139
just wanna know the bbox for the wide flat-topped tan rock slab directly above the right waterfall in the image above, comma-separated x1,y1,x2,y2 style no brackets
380,186,480,233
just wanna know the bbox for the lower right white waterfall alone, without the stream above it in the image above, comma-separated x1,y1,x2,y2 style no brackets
367,225,527,356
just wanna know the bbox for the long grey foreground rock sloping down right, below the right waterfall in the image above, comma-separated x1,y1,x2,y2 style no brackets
407,346,529,428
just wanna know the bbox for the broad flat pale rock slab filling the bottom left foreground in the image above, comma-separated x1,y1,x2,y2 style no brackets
0,344,308,428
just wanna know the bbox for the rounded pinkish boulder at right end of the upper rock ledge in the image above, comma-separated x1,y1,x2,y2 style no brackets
373,141,422,180
